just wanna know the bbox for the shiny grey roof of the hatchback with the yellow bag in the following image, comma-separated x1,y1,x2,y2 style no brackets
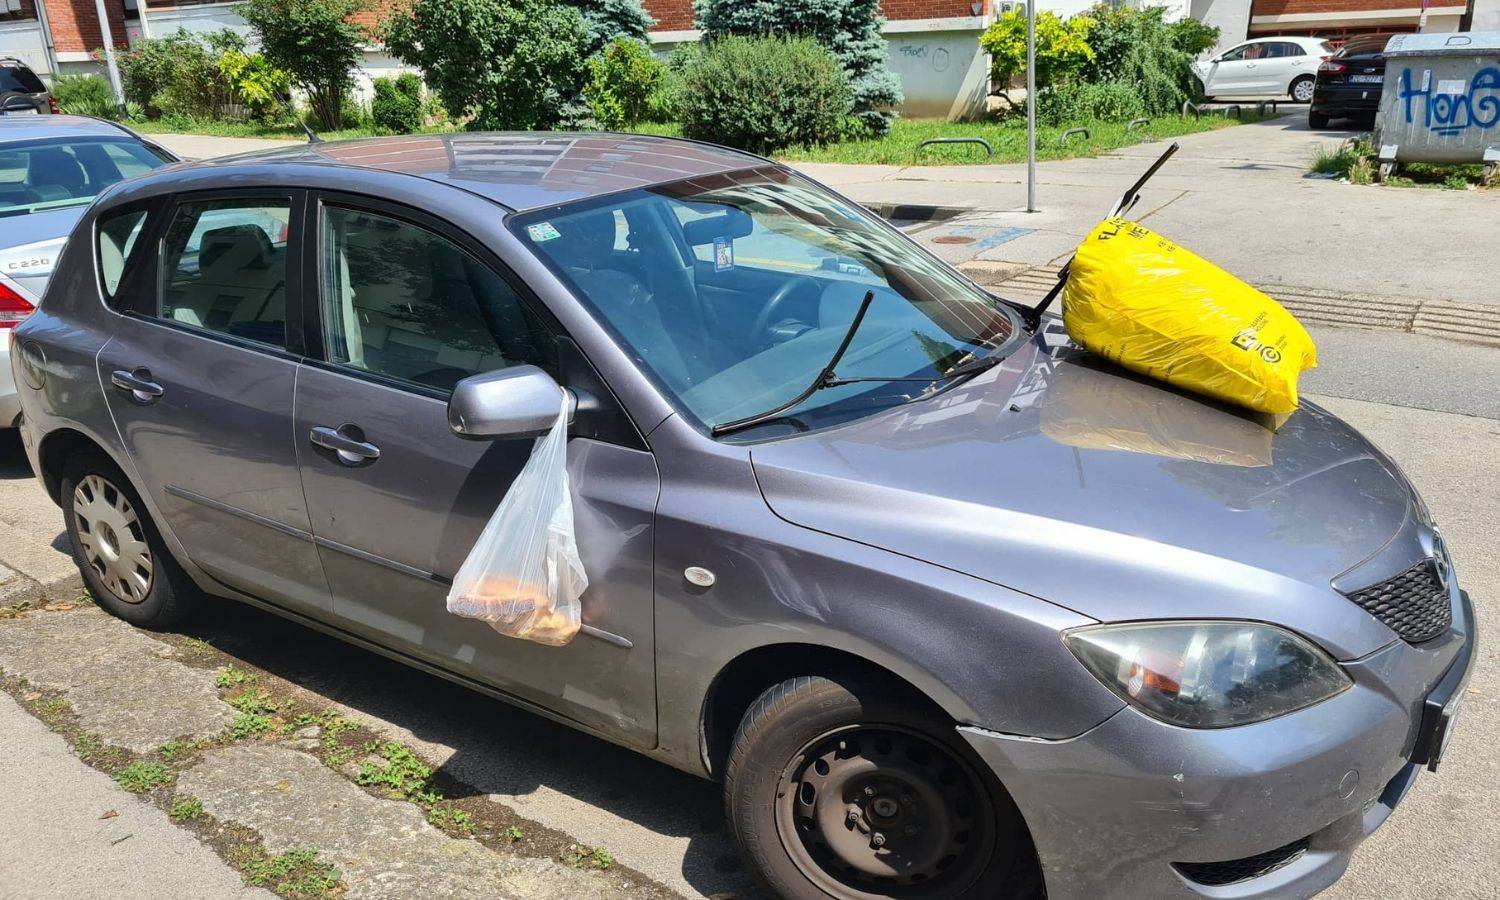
193,132,768,210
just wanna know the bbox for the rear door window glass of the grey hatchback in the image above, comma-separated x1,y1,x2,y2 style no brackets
158,200,291,348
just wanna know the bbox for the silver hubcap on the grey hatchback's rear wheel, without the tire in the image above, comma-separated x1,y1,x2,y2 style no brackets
74,476,156,603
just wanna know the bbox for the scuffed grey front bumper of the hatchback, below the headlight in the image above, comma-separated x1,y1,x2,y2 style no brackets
960,591,1475,900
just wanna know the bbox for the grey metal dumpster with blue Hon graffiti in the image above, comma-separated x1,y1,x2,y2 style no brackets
1374,32,1500,185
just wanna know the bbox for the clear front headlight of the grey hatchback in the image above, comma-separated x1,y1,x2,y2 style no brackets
1064,621,1353,728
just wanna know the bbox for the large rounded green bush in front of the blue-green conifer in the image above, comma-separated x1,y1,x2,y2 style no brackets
683,36,854,153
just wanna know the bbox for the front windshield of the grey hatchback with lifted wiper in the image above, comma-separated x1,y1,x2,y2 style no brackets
512,167,1017,437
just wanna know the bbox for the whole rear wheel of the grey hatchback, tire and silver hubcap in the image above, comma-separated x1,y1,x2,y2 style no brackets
62,450,197,629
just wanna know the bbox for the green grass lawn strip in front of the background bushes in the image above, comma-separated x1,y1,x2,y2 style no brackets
129,113,1254,165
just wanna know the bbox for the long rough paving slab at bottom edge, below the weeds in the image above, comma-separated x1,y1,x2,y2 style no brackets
177,744,639,900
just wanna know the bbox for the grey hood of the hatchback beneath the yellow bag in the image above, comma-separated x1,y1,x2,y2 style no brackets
750,323,1415,656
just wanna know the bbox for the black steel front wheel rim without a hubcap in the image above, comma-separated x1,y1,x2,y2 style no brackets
776,725,998,900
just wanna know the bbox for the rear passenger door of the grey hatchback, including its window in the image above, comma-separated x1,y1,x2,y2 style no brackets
98,191,329,614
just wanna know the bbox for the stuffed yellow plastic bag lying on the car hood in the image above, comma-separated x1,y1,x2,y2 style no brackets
1062,218,1317,414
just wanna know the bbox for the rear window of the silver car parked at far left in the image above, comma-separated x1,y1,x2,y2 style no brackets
0,135,167,218
